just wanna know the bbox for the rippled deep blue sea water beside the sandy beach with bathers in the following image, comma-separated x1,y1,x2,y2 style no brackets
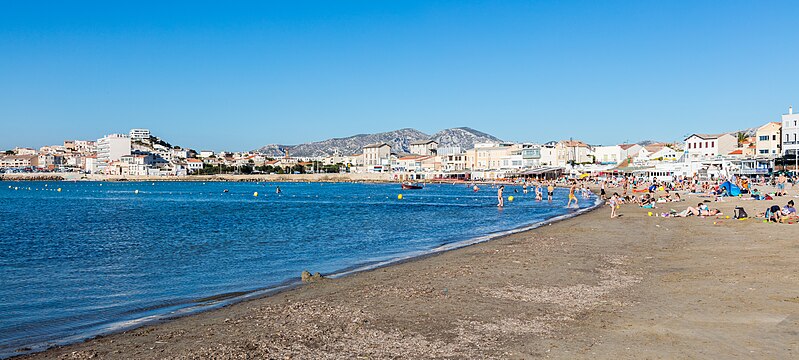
0,182,594,357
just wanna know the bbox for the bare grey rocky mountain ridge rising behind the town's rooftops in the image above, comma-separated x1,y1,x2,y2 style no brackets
257,127,502,157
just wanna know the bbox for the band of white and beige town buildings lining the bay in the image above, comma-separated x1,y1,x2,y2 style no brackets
0,107,799,181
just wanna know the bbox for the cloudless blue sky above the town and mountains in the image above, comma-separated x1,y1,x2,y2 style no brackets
0,0,799,150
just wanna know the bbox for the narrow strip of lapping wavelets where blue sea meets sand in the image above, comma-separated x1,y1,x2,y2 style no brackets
0,190,604,358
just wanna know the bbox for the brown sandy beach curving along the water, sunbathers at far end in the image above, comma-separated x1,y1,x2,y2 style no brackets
17,189,799,359
